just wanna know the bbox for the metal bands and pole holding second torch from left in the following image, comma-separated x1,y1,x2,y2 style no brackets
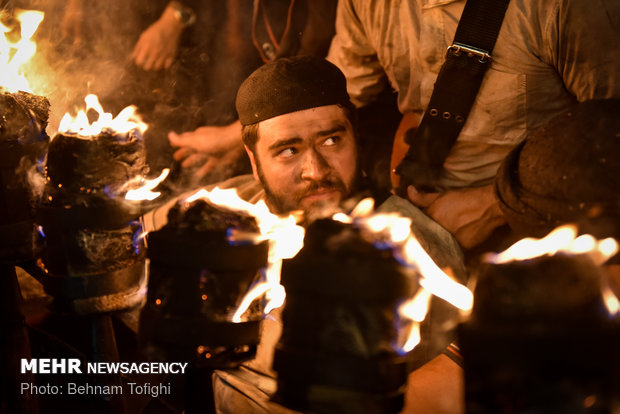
31,200,153,413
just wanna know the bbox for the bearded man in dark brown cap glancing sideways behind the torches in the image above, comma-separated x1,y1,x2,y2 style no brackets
146,57,465,413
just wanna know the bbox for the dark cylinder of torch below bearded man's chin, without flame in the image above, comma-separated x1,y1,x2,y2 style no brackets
274,220,413,414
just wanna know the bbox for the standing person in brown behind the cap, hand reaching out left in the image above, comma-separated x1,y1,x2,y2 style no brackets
169,0,336,182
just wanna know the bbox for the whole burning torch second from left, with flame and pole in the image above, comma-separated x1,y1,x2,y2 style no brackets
30,95,167,412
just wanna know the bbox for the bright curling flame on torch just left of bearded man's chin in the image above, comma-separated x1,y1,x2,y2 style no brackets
186,187,305,323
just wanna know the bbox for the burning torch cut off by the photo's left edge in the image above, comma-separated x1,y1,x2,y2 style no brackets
0,11,50,412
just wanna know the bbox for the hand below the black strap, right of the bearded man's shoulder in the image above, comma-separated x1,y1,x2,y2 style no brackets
407,185,506,249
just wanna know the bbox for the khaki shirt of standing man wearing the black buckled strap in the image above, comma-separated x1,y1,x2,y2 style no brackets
328,0,620,188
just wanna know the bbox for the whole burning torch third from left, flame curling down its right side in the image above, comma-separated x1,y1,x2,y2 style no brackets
140,188,303,413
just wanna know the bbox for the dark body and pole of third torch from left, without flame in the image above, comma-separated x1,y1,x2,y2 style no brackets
140,227,269,414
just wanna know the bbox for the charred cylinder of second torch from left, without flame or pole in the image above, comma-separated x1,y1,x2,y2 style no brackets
36,130,147,314
